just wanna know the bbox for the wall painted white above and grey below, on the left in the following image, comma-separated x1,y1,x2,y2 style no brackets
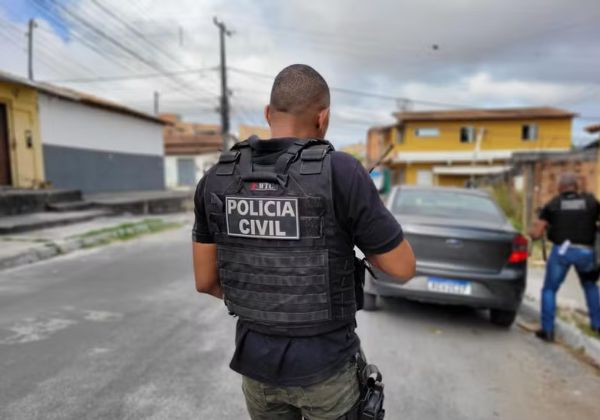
38,93,164,192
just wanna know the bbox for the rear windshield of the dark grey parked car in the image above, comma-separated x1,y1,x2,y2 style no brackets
392,190,504,223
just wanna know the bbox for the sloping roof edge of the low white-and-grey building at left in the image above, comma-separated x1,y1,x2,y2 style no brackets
0,70,169,125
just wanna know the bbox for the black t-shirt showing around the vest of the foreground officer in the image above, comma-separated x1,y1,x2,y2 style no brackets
193,138,403,386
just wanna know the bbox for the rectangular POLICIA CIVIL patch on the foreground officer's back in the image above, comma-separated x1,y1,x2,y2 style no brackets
225,197,300,239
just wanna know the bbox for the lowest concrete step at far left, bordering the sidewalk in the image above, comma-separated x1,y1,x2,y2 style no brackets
0,209,112,235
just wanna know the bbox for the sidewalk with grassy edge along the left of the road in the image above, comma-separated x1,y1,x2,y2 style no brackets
0,213,193,270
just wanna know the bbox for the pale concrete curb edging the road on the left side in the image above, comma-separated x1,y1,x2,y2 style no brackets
0,218,183,271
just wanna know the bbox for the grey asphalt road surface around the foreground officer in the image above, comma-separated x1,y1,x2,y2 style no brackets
0,229,600,420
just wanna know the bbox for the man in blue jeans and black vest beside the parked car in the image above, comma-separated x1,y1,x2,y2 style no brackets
529,173,600,341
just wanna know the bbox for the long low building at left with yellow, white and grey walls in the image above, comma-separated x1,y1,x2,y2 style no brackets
0,71,168,193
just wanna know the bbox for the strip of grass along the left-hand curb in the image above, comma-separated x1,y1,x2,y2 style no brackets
74,219,181,248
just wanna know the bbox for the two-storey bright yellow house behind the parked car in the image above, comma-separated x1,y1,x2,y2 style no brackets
367,107,575,186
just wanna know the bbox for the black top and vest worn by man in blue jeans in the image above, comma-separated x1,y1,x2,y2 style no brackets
540,191,600,246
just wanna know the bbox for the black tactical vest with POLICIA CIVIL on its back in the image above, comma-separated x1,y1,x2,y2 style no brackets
204,139,357,336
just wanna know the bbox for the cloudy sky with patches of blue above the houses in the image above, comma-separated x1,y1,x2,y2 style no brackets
0,0,600,146
